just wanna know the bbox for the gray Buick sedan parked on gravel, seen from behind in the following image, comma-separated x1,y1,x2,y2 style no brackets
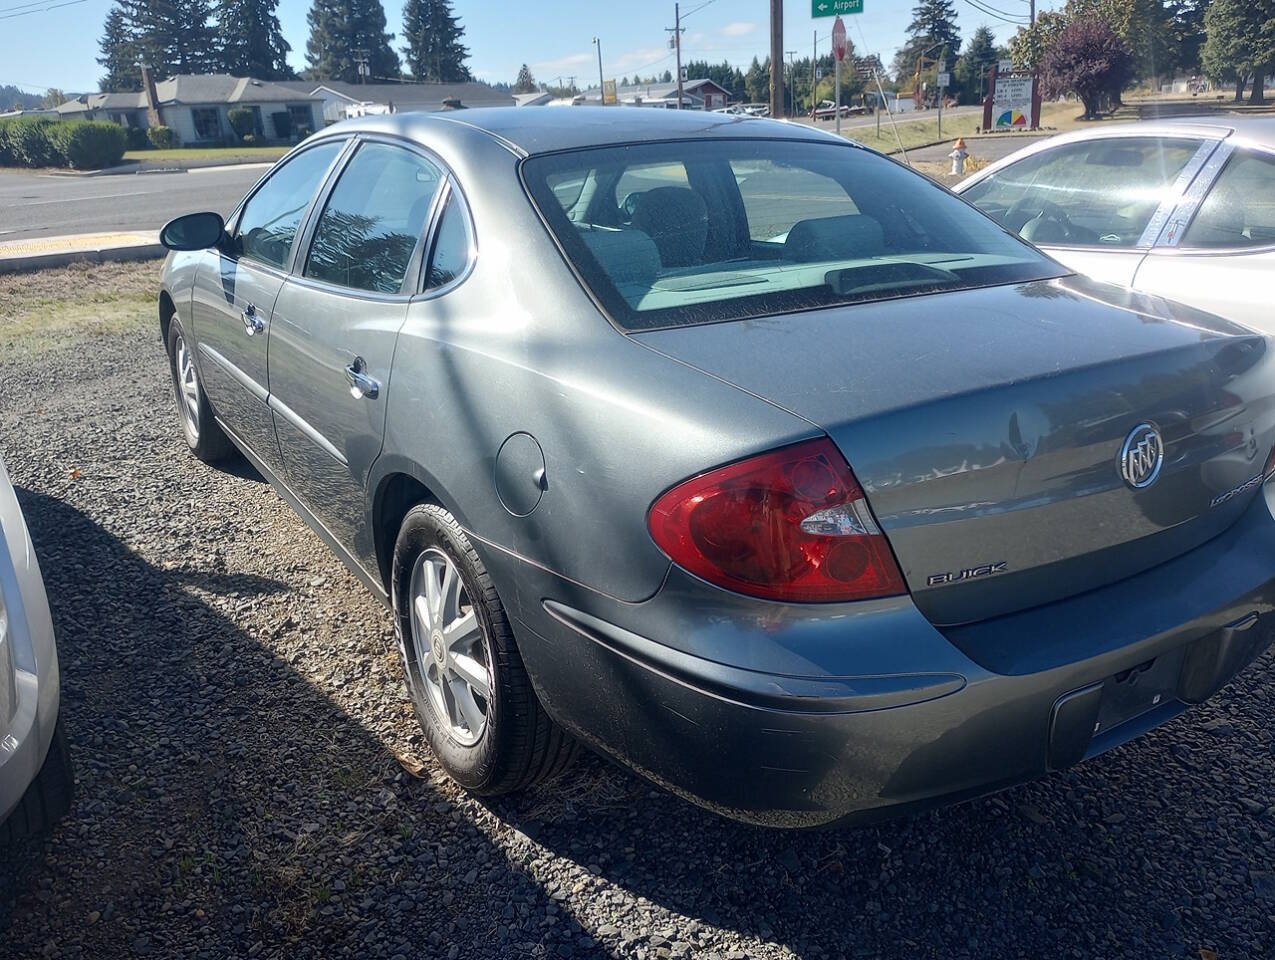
159,108,1275,826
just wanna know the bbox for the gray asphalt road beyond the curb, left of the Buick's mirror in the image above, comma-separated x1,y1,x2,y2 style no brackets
0,163,266,241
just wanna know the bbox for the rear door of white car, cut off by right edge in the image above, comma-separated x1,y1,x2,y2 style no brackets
1135,143,1275,333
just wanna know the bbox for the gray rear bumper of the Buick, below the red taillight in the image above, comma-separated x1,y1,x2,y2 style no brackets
488,481,1275,826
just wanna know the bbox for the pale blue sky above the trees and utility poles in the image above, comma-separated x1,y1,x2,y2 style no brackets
0,0,1061,92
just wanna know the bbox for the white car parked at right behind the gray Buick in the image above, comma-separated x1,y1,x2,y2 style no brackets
954,116,1275,333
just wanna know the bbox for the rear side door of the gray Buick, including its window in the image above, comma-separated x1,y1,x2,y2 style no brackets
270,139,445,562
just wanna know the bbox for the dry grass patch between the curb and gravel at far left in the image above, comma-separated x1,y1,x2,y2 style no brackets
0,261,159,353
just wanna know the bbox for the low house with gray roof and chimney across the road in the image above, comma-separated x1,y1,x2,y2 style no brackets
56,68,323,144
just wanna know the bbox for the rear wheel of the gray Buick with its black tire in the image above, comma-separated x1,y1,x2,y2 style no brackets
391,504,579,797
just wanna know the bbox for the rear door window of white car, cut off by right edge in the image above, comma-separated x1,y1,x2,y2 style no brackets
1182,150,1275,247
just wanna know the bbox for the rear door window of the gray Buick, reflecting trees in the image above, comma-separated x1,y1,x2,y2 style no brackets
305,143,442,293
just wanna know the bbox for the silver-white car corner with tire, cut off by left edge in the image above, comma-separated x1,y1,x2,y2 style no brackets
0,463,75,843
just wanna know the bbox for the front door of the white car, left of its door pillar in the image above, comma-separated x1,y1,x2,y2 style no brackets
961,136,1218,287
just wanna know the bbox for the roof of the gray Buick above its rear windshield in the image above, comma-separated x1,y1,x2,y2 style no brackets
314,106,848,156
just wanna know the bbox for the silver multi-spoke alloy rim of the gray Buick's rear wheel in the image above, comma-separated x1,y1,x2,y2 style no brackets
409,547,492,747
